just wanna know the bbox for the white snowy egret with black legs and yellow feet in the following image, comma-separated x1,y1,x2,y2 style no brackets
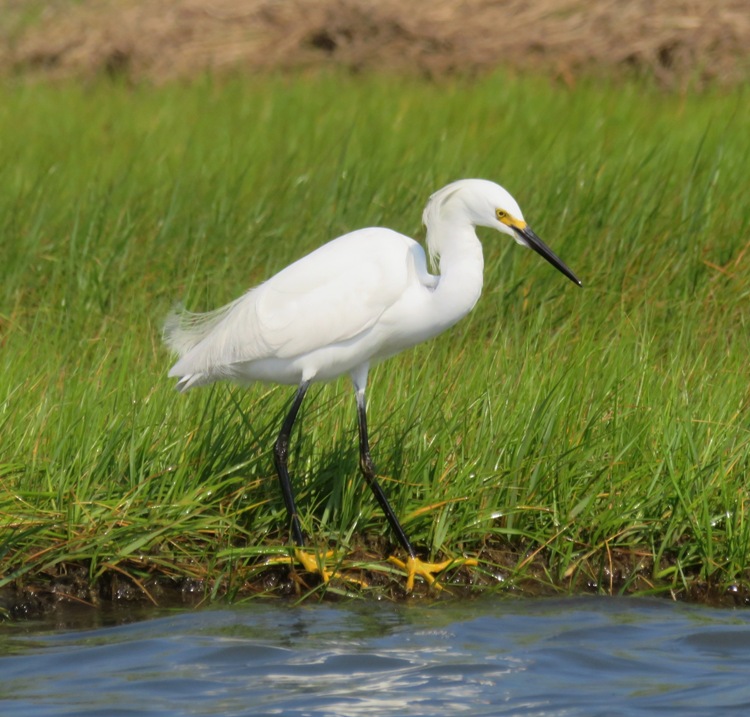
164,179,581,591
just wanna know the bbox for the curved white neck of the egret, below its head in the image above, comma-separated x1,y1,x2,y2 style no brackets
427,224,484,326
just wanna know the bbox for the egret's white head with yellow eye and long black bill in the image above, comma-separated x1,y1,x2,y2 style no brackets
422,179,582,286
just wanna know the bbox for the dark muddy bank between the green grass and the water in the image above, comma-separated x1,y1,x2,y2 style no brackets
5,541,750,621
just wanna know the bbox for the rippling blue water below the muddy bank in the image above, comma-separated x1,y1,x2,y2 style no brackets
0,598,750,717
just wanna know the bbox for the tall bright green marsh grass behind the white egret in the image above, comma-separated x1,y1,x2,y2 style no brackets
0,74,750,599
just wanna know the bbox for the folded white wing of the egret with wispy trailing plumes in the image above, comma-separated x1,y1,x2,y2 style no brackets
165,228,432,376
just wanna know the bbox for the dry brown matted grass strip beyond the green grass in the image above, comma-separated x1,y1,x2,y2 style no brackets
0,0,750,88
